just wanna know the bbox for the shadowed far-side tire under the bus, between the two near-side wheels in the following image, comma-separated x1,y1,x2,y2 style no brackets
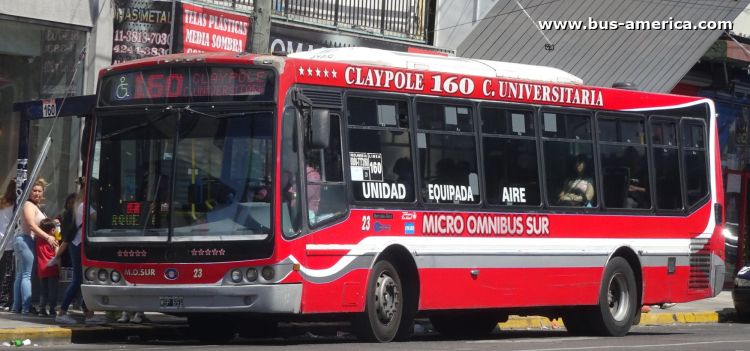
430,313,498,338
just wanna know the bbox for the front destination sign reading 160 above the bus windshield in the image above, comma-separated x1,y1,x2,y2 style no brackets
99,67,274,106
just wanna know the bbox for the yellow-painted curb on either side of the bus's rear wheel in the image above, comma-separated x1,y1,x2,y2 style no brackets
498,312,733,329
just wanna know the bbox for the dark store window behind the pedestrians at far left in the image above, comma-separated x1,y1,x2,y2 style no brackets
0,20,86,216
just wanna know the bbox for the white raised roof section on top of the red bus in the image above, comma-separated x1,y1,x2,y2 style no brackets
289,47,583,85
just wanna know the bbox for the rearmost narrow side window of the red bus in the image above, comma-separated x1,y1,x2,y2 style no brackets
682,121,708,206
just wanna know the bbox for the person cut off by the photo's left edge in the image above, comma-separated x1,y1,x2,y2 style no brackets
0,182,16,311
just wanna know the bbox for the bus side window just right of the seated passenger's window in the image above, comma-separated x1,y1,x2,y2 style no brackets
598,117,651,208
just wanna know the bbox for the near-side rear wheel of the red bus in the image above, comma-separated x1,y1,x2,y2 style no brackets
589,257,638,336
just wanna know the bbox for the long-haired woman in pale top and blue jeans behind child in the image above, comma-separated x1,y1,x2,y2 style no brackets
11,178,58,314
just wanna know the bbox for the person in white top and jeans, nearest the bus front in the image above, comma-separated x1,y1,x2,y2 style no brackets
55,184,107,324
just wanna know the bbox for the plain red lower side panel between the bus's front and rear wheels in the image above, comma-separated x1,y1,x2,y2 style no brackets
419,267,602,310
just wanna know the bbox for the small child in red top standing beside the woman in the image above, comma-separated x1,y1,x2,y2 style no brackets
36,218,60,317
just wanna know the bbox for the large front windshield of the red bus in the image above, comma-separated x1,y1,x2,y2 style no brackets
88,108,273,242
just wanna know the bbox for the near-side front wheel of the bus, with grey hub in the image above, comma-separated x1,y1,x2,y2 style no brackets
352,259,411,342
